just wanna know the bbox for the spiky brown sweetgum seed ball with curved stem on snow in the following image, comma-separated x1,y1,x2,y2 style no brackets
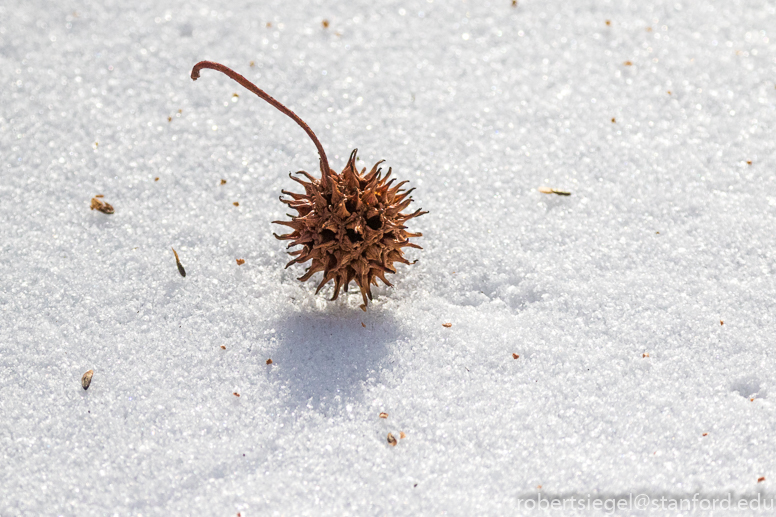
191,61,427,309
